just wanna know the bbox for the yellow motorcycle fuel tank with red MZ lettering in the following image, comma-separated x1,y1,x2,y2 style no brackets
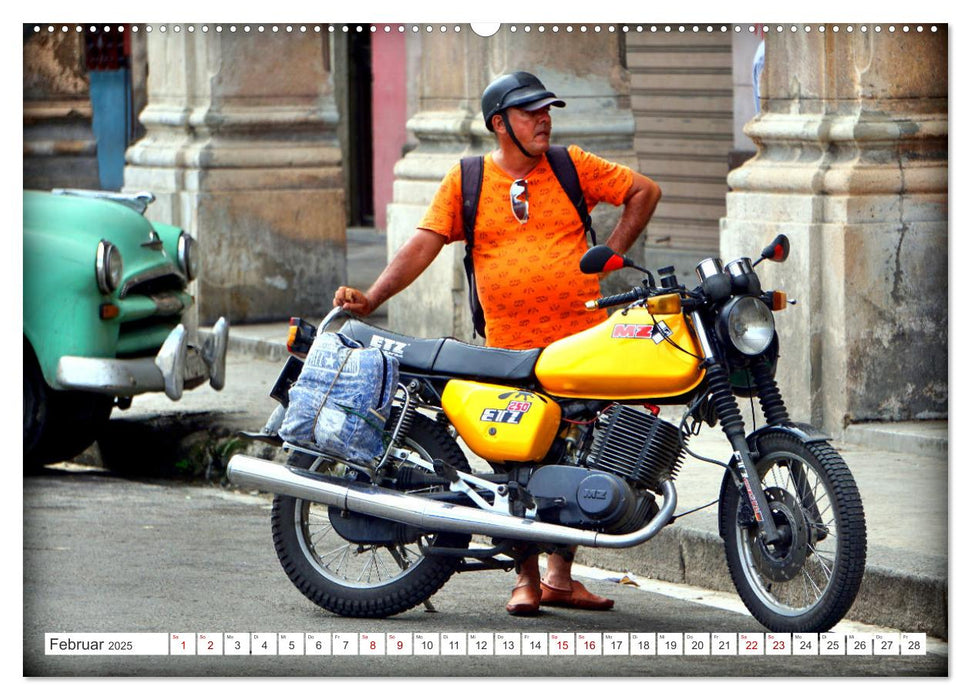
536,308,704,401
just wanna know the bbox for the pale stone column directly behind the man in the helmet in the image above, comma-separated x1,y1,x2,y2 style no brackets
388,25,643,340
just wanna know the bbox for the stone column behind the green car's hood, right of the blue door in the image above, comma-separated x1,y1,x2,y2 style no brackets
125,26,347,323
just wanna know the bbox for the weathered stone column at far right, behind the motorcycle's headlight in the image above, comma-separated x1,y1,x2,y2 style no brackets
721,25,948,435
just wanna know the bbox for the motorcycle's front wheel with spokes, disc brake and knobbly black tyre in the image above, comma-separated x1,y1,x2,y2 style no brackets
719,433,866,632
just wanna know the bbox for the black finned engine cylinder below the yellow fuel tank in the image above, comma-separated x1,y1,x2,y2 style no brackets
584,405,684,493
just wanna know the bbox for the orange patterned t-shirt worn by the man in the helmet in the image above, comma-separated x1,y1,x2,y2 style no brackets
418,146,634,350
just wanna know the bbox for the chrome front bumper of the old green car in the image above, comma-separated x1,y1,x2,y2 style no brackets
57,318,229,401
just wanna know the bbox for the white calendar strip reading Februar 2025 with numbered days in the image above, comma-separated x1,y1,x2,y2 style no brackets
44,632,927,656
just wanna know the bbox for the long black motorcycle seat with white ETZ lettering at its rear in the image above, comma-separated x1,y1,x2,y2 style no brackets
340,319,541,382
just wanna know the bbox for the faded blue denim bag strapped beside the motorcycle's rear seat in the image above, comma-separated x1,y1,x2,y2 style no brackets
279,333,398,463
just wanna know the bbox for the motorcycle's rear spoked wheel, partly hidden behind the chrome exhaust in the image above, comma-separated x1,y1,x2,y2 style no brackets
272,415,470,617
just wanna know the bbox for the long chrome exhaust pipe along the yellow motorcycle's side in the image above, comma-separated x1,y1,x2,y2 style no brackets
226,455,678,548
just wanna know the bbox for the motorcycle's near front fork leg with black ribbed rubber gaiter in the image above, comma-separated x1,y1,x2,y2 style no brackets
691,311,781,544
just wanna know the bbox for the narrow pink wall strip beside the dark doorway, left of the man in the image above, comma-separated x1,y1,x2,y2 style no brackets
371,31,408,231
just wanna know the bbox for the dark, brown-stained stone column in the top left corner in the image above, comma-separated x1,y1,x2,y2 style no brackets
24,25,100,190
